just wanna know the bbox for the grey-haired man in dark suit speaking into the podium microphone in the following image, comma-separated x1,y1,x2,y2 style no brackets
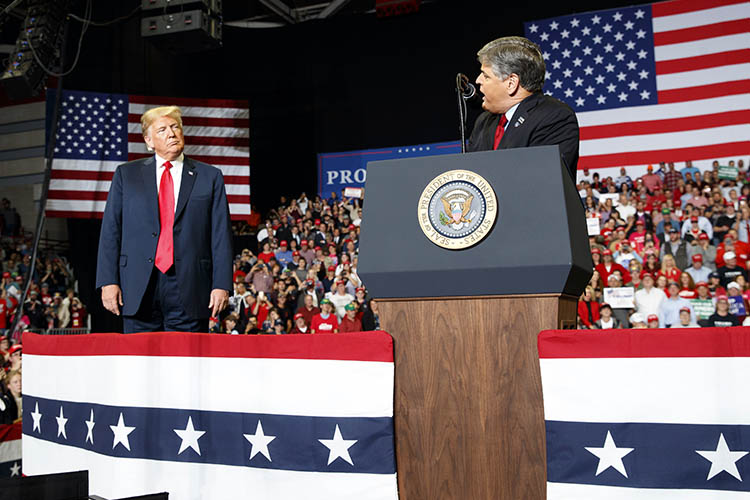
467,36,579,183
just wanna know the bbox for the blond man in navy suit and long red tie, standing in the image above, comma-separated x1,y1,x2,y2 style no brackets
96,106,232,333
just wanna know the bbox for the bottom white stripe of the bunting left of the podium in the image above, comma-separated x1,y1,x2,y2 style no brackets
23,436,398,500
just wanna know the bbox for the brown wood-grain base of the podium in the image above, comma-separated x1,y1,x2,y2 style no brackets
378,294,577,500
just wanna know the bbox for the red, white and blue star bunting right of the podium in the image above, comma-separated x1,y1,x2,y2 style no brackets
539,327,750,500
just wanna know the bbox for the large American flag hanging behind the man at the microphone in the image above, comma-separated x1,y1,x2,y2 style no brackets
525,0,750,169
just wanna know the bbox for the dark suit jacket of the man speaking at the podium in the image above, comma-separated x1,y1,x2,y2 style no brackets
466,93,579,183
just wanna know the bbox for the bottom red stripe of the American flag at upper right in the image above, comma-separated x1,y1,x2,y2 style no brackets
578,141,750,170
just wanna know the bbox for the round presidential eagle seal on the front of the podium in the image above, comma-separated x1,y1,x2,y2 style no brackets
417,170,498,250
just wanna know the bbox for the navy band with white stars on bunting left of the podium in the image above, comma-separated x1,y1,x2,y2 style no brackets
24,394,395,474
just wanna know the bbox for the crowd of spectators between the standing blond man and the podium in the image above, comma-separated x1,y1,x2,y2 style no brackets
219,193,380,334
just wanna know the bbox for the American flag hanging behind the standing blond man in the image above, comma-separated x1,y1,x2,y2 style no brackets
46,90,250,219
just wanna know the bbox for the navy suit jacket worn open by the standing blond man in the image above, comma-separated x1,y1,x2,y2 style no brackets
96,156,232,319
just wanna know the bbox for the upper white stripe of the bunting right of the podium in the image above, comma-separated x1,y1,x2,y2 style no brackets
540,358,750,424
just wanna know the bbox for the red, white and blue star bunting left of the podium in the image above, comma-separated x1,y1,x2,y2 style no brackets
22,332,398,500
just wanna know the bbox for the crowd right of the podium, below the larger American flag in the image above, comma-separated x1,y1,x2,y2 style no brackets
578,160,750,329
